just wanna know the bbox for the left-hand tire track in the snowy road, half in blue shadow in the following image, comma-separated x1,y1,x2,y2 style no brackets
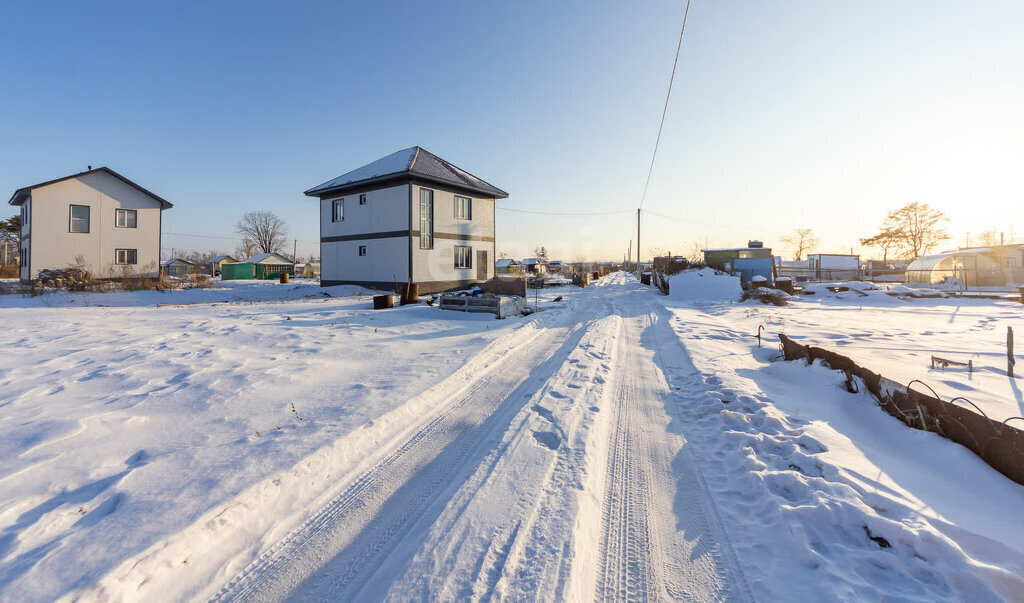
213,307,598,601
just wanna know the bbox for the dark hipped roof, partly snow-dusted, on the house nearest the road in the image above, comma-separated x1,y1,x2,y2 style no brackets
304,146,509,199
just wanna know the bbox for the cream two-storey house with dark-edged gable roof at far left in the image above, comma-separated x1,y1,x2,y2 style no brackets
9,167,172,283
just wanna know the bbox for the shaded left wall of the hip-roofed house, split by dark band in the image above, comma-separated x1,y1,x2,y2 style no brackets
321,184,409,284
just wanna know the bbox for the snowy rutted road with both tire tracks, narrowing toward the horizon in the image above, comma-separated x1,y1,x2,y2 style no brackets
214,276,743,601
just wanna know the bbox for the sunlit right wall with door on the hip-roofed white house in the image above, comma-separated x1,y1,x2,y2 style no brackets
413,184,495,283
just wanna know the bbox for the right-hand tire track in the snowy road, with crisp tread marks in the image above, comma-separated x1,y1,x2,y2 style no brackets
594,297,750,601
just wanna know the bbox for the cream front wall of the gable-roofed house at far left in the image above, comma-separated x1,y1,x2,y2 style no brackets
23,171,161,278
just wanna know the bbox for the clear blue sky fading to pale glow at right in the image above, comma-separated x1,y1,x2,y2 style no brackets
0,0,1024,259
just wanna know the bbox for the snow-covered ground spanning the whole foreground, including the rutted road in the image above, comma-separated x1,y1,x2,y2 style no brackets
0,273,1024,600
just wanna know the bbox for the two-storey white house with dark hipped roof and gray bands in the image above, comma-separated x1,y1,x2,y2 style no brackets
305,146,508,293
